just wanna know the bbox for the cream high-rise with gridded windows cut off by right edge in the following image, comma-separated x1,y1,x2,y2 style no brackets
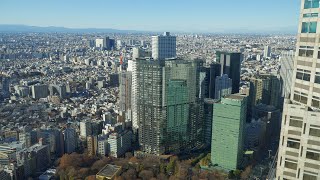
276,0,320,180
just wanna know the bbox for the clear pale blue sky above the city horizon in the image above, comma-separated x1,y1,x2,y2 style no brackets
0,0,300,32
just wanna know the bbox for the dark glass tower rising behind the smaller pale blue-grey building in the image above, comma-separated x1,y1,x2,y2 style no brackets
216,51,243,94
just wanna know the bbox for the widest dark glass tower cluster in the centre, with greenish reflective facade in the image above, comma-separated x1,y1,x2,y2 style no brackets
133,59,202,155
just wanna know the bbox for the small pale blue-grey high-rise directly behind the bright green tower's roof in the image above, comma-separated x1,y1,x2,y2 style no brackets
215,74,232,99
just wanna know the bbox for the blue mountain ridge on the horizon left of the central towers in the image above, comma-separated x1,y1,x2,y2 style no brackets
0,24,148,33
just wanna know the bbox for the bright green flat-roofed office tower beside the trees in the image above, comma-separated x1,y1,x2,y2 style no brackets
211,94,247,171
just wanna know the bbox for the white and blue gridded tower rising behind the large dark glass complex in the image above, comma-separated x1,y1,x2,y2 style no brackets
152,32,177,60
